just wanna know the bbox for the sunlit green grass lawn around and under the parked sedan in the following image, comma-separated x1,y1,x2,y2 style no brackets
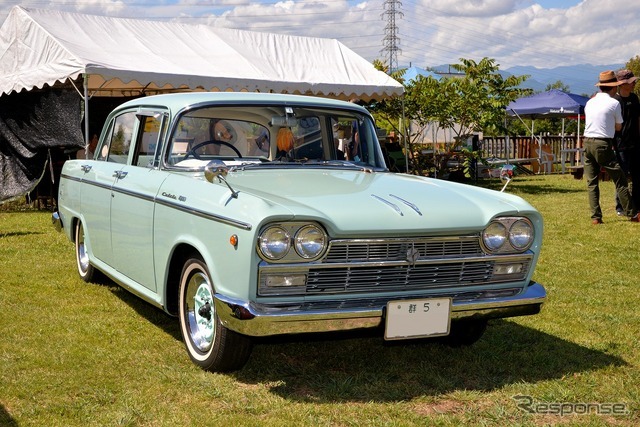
0,175,640,427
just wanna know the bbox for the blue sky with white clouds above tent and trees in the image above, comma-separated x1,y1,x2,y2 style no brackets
0,0,640,79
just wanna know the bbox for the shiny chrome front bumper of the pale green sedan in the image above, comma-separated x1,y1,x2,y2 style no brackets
215,281,547,337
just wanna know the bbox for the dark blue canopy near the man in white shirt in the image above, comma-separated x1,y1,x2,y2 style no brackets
507,89,589,119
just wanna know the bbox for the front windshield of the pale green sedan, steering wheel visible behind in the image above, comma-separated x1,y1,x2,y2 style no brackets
165,105,386,169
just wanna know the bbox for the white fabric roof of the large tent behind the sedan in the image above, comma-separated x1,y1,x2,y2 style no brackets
0,6,404,101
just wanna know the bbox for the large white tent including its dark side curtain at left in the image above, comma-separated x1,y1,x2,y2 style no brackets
0,6,404,201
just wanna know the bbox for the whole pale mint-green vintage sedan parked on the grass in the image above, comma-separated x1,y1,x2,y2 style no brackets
54,93,546,371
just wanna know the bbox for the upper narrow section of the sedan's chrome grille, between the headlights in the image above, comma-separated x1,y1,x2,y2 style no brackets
323,236,482,263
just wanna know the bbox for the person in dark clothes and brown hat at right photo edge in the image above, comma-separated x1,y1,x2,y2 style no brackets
614,70,640,215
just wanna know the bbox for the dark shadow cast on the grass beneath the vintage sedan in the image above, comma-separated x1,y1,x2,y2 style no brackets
105,281,626,402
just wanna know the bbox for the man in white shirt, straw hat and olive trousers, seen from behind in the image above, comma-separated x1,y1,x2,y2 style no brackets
584,71,638,225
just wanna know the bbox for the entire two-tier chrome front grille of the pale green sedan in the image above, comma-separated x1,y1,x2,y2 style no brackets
259,235,533,295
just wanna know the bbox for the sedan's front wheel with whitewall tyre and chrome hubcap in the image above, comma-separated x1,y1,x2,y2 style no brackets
179,257,251,372
